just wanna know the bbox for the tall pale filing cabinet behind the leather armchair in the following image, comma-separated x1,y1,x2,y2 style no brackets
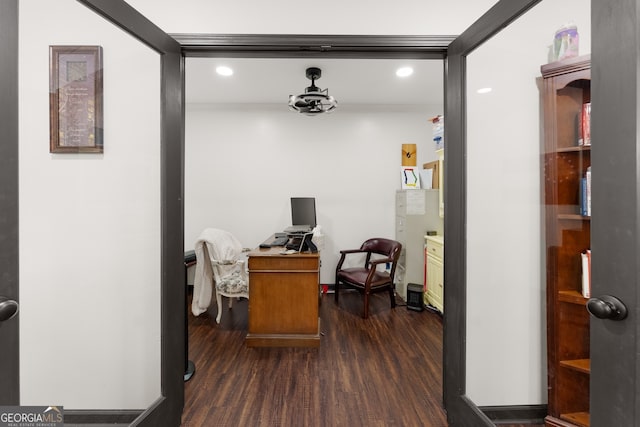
395,189,443,301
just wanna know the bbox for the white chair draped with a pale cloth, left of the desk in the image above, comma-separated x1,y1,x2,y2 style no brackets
191,228,249,323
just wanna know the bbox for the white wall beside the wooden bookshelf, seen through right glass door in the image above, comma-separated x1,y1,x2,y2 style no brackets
467,0,590,406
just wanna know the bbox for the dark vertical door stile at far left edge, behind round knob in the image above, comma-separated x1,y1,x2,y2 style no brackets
0,0,20,405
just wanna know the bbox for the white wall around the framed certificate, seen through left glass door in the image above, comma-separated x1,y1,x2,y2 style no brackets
19,0,160,409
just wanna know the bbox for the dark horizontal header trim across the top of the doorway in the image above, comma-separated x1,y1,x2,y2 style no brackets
171,33,455,59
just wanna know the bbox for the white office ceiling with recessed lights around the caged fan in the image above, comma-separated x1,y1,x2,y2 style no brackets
185,58,444,108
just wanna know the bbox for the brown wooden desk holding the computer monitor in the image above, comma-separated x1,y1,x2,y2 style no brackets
246,247,320,347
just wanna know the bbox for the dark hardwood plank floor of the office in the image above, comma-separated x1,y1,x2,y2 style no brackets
182,292,544,427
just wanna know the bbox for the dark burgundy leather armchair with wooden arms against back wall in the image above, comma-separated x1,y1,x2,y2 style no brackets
335,238,402,319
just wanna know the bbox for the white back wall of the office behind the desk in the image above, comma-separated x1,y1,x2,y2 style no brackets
185,104,442,283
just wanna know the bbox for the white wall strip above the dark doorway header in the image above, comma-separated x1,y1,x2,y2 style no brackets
128,0,496,35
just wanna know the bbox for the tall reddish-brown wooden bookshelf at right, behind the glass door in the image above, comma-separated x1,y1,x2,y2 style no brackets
541,56,591,427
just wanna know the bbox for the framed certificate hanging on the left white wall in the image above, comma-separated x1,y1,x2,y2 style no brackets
49,46,104,153
